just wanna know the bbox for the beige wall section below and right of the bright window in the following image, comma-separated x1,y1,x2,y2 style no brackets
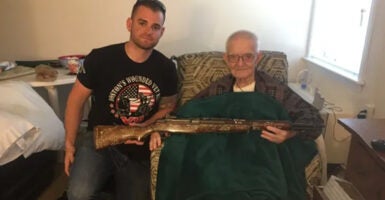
304,0,385,118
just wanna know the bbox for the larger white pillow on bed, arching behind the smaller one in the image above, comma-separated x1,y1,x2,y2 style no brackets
0,81,64,160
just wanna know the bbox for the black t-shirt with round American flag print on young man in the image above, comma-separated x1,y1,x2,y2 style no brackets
77,43,177,159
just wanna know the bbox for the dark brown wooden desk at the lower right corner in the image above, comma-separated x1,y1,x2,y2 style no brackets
338,118,385,200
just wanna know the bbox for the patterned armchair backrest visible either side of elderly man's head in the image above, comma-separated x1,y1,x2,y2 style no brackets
172,51,288,105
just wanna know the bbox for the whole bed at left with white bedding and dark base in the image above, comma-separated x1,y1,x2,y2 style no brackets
0,81,64,200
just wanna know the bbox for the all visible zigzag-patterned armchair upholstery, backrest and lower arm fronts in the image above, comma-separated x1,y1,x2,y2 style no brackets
151,51,321,199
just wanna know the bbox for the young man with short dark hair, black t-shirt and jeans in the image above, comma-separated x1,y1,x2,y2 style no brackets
65,0,177,200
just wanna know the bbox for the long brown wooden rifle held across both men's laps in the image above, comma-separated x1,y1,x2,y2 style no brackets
94,118,319,149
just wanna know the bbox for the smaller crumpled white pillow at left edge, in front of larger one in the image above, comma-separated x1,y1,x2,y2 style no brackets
0,110,40,165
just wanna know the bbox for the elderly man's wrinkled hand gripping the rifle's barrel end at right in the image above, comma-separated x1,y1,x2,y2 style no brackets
261,126,295,144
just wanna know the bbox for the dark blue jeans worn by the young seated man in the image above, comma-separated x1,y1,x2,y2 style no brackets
67,131,150,200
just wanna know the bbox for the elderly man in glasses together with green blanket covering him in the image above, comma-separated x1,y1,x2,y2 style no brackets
150,30,322,200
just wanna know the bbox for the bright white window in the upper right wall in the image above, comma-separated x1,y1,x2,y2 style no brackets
306,0,374,82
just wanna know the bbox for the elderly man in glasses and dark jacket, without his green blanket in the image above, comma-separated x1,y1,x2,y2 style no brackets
196,30,323,143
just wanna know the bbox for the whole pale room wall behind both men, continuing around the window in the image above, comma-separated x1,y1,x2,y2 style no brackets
0,0,385,117
